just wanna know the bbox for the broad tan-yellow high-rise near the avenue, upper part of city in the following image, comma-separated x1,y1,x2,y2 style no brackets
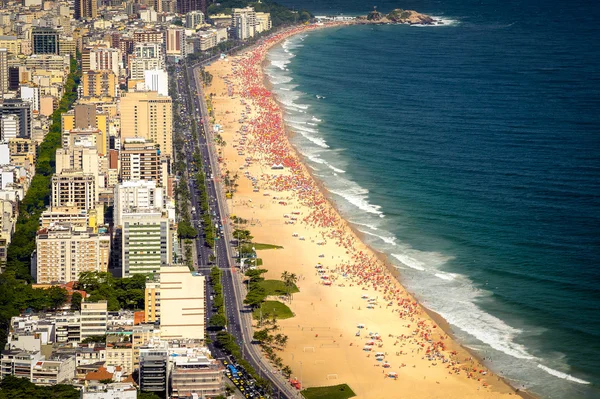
121,91,173,156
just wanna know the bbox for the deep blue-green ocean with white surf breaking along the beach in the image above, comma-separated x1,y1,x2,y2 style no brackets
267,0,600,398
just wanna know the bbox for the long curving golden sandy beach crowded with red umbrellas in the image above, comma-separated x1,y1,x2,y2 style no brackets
206,26,516,398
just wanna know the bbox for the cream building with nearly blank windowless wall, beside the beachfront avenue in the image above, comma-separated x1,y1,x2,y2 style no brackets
160,266,205,339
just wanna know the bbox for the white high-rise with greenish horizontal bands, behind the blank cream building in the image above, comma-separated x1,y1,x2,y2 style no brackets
121,211,172,277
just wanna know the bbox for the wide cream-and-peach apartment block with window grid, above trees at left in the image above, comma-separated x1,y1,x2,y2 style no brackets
35,225,110,283
